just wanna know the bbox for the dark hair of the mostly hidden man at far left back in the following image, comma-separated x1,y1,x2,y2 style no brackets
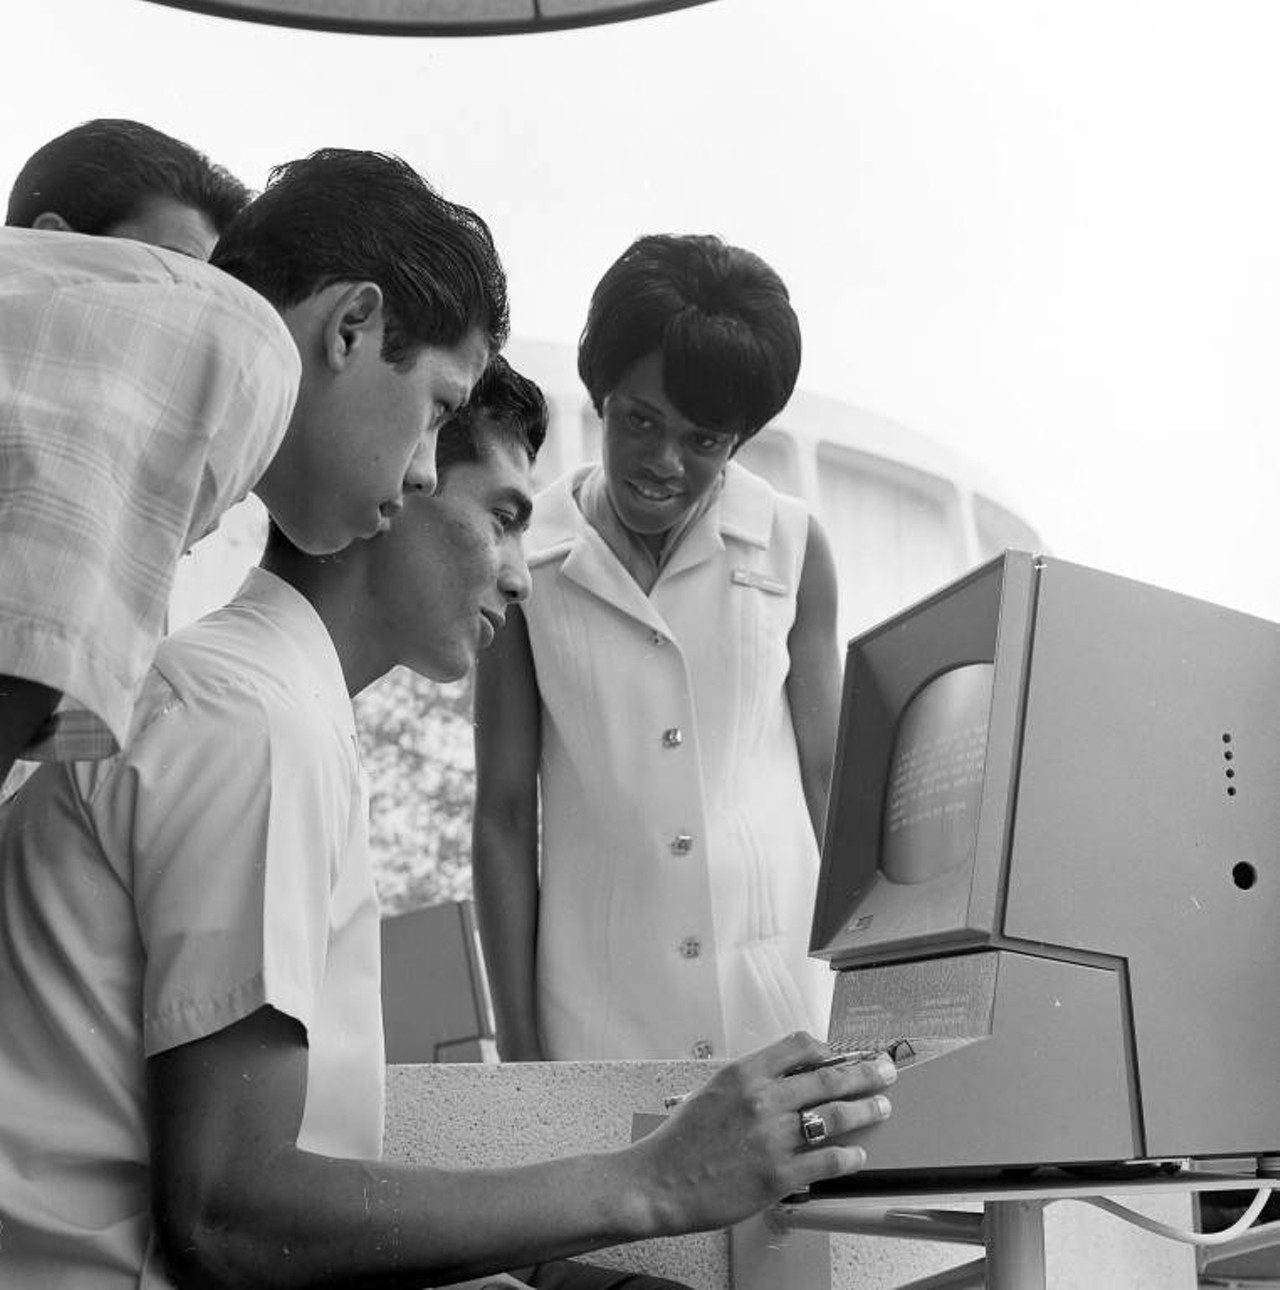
5,117,250,236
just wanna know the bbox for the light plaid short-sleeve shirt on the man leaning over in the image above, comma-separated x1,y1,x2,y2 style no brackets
0,228,301,760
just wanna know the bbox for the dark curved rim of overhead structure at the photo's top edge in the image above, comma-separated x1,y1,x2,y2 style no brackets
140,0,710,36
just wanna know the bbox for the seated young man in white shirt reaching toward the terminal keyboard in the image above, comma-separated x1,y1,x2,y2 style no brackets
0,361,892,1290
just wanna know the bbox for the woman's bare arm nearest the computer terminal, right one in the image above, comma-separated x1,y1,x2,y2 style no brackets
787,519,840,846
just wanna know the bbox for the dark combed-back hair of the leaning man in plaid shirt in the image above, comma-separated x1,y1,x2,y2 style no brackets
209,148,510,364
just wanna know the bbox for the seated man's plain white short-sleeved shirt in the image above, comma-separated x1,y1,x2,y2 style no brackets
0,570,383,1290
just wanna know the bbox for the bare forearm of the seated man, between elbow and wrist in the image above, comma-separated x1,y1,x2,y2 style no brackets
161,1149,655,1290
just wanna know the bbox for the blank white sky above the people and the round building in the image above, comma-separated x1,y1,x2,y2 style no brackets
0,0,1280,619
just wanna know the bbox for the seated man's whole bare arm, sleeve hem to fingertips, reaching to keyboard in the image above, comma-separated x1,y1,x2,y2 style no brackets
147,1007,889,1290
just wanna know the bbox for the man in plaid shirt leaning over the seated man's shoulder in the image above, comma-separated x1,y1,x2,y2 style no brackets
0,150,507,780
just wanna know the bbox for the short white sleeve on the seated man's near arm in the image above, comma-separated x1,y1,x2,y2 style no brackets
92,665,359,1057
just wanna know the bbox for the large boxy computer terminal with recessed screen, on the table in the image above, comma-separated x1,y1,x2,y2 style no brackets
810,551,1280,1173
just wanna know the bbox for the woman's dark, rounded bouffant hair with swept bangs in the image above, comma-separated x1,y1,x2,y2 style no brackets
578,233,800,439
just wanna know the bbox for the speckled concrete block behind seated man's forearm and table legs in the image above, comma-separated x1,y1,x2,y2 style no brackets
386,1062,1196,1290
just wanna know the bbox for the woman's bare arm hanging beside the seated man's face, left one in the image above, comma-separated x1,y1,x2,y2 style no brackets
471,606,545,1062
